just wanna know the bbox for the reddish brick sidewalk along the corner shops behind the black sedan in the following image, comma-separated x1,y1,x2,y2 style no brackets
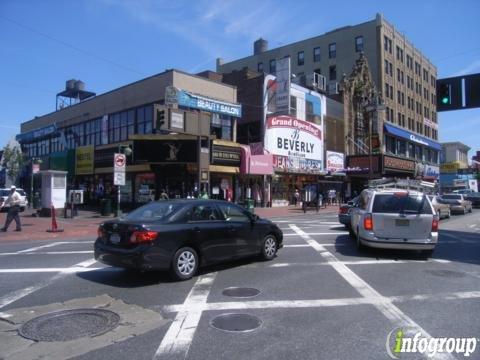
0,205,338,242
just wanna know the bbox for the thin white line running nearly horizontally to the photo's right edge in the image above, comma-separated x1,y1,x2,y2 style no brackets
162,291,480,313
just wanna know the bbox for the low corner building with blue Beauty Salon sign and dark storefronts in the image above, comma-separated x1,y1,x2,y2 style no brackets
17,70,242,203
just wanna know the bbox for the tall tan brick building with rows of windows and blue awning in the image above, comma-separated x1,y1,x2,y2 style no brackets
217,14,440,193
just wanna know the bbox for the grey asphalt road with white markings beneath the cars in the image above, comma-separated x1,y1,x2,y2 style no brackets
0,210,480,360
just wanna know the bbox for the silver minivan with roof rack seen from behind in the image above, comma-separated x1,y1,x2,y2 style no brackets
351,189,439,256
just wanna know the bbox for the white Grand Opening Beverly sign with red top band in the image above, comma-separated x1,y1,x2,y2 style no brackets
265,115,323,170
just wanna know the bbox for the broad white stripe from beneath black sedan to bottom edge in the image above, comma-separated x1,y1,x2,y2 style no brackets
153,273,217,360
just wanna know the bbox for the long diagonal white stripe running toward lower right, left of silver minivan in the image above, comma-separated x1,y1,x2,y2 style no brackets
290,224,454,359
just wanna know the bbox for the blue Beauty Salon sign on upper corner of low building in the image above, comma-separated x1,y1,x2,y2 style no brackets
173,90,242,117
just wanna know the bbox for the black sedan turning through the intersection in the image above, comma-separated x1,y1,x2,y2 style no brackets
95,200,283,280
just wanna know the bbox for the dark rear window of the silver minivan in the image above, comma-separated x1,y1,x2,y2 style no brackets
372,194,432,214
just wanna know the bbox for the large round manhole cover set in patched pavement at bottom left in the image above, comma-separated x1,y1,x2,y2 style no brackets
18,309,120,341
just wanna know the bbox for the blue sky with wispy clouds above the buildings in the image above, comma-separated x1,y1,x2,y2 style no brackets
0,0,480,155
